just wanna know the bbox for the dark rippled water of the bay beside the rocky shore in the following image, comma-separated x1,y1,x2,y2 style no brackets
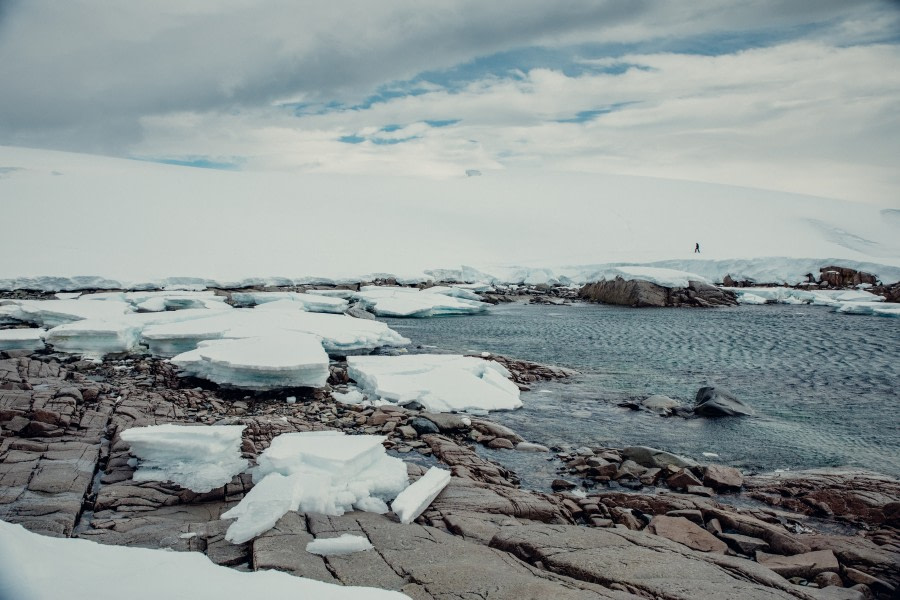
387,304,900,487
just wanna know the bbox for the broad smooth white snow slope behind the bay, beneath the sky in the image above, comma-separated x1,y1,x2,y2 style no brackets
0,147,900,289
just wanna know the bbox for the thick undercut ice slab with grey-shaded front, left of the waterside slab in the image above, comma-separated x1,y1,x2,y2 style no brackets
172,332,329,389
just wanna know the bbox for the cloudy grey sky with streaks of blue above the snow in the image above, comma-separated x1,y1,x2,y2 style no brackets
0,0,900,206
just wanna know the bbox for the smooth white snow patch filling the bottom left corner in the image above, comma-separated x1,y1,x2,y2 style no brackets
0,521,409,600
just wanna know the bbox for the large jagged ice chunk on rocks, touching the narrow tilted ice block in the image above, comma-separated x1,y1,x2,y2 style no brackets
222,431,408,544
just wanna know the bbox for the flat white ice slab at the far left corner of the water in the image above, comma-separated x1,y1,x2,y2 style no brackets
353,286,490,317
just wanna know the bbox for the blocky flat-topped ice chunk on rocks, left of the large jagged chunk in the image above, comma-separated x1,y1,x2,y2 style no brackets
119,424,247,493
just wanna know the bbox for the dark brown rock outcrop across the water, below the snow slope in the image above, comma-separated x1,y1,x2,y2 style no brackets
578,277,737,308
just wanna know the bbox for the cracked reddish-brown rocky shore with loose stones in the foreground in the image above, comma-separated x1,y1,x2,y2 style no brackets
0,352,900,600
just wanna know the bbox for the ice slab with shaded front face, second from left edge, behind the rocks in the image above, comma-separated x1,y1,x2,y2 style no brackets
46,319,141,358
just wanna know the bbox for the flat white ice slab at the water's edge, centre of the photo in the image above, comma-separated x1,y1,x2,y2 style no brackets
347,354,522,412
